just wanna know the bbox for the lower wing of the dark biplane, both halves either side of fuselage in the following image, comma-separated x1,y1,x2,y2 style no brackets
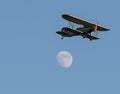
65,27,99,40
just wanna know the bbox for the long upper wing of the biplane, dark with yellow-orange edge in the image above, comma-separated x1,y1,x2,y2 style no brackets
62,14,109,31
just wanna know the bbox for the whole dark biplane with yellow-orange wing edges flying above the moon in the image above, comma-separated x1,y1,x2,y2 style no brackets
56,14,110,40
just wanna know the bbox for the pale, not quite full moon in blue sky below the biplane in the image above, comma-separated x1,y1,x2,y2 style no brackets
57,51,73,68
